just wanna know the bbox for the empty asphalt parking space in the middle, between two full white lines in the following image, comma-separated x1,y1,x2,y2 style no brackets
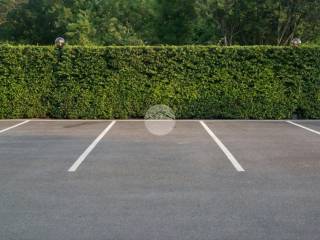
80,122,238,175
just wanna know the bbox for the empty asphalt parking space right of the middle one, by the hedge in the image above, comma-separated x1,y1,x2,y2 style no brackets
207,121,320,176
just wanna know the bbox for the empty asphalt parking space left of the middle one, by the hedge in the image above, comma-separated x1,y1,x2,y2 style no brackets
0,121,111,189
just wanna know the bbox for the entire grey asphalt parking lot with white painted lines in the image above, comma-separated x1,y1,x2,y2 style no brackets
0,120,320,240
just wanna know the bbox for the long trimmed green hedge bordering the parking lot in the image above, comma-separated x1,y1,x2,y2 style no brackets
0,45,320,119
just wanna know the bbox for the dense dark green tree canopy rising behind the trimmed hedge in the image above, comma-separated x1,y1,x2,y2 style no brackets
0,0,320,45
